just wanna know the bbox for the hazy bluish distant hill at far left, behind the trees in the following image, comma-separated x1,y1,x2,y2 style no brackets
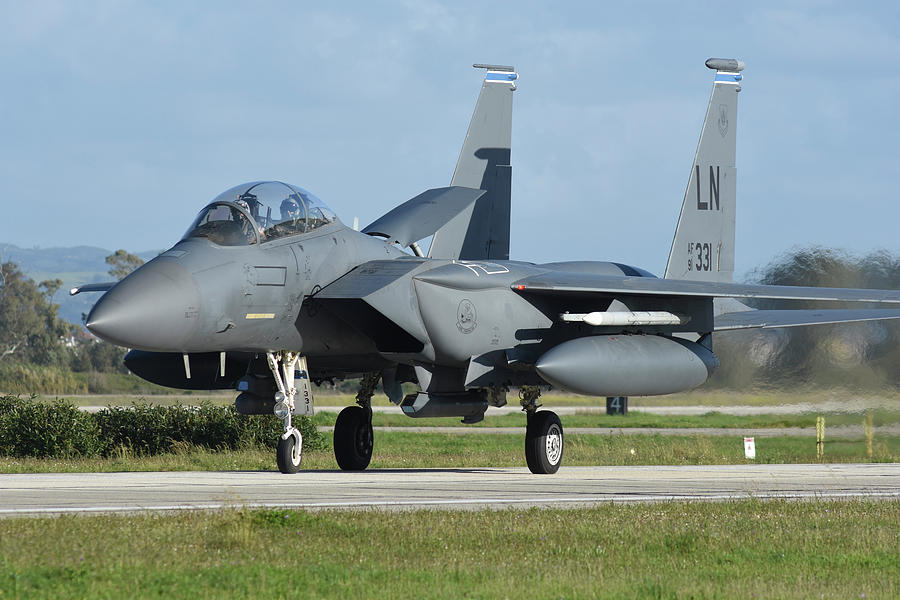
0,242,160,324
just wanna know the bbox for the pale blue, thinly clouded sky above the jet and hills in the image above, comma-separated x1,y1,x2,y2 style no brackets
0,0,900,279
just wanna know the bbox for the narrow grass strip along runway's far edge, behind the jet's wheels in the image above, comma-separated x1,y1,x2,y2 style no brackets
0,432,900,473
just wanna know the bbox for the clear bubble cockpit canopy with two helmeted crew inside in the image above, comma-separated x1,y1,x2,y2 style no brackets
183,181,336,246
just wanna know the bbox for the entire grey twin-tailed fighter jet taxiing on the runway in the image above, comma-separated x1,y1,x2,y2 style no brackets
73,59,900,473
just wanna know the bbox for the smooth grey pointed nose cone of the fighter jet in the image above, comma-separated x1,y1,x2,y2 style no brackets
86,259,200,352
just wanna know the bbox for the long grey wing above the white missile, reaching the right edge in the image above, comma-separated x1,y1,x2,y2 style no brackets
511,271,900,304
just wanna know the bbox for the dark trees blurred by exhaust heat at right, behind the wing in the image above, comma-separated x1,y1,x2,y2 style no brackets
711,247,900,389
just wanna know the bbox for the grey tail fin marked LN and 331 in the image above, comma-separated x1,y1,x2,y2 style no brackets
666,58,744,282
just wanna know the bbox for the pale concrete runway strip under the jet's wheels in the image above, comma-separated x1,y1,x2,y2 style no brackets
0,463,900,517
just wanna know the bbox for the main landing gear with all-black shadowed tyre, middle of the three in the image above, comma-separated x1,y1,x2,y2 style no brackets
334,371,381,471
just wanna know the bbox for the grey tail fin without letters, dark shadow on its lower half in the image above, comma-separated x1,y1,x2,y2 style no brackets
428,65,518,260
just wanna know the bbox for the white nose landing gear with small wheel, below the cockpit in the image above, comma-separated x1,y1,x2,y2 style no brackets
266,350,313,473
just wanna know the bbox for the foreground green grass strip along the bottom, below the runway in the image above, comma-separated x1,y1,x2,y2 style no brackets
0,500,900,598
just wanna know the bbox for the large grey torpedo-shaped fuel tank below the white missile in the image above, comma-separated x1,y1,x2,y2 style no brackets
535,335,719,396
